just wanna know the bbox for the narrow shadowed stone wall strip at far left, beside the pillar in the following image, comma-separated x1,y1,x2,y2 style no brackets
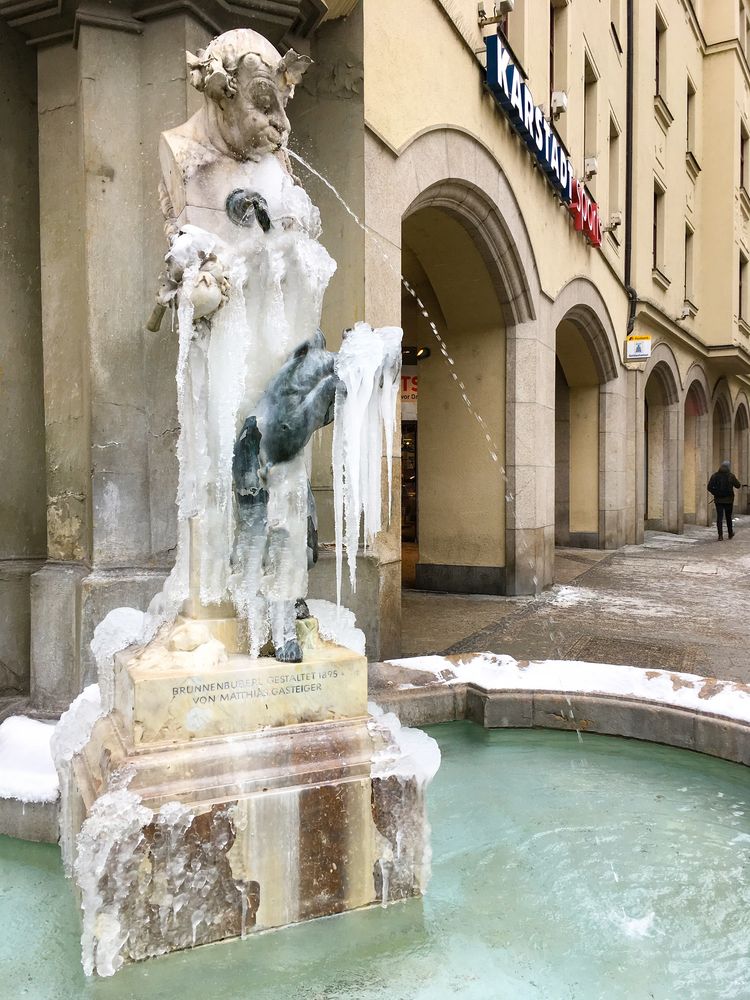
0,24,46,695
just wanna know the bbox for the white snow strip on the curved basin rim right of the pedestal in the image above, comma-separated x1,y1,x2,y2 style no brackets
385,653,750,725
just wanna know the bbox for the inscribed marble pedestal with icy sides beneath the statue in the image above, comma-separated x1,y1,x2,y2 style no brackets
56,620,440,975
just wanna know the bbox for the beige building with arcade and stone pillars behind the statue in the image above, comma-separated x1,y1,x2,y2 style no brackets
0,0,750,711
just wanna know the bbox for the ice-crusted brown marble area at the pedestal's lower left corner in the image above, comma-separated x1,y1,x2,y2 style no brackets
75,787,258,976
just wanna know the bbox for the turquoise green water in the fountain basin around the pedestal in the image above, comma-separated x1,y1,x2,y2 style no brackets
0,723,750,1000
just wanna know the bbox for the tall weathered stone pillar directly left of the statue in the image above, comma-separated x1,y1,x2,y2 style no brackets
31,16,208,709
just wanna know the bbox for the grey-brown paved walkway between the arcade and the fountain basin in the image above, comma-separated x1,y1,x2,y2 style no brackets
402,517,750,683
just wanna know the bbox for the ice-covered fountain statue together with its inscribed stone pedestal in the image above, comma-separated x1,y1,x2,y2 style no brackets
53,30,439,975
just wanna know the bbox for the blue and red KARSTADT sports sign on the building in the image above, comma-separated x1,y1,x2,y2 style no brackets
485,35,602,247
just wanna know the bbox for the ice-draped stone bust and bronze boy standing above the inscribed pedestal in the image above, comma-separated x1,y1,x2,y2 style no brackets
149,29,400,662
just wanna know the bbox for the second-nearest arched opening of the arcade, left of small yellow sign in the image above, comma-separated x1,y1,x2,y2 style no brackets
555,319,601,548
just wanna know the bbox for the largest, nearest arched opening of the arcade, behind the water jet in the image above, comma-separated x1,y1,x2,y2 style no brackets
402,205,506,594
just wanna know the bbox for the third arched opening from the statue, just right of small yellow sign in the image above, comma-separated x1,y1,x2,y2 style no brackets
643,361,682,531
